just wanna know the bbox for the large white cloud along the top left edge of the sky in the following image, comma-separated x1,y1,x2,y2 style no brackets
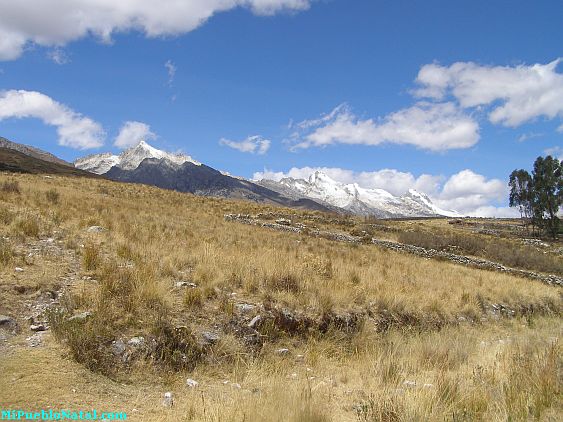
0,0,313,60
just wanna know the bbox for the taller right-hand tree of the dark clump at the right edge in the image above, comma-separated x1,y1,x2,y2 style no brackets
532,155,563,237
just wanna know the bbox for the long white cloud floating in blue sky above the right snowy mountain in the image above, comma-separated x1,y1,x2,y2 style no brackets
292,102,479,151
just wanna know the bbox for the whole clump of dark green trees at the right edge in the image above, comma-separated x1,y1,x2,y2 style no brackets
508,155,563,238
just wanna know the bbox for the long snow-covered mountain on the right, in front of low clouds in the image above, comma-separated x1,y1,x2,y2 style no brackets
257,171,458,218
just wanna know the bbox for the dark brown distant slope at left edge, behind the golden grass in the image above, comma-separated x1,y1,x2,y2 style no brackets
0,147,101,177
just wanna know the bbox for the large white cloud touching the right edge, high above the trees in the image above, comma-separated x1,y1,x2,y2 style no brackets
415,59,563,127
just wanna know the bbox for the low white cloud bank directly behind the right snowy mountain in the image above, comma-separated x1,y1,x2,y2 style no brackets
253,167,508,217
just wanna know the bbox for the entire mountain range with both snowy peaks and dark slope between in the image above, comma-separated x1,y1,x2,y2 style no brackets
74,141,458,218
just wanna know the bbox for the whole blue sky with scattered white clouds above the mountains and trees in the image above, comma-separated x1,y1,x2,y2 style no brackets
0,0,563,215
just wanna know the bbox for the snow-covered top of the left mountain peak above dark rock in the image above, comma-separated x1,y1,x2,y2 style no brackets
74,141,201,174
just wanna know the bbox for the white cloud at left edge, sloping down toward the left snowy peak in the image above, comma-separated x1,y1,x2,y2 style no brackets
0,90,105,149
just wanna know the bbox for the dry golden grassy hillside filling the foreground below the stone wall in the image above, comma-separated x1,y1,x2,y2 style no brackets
0,174,563,421
